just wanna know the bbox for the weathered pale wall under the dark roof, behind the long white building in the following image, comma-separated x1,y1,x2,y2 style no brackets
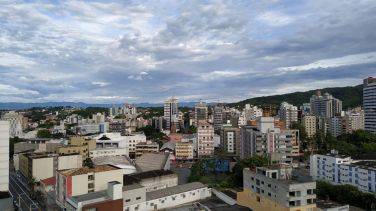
140,174,178,192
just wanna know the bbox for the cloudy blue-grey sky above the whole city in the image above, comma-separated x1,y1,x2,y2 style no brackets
0,0,376,103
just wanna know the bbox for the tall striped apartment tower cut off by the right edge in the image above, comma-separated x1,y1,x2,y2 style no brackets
363,77,376,134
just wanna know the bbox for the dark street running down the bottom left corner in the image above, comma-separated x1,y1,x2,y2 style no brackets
9,176,45,211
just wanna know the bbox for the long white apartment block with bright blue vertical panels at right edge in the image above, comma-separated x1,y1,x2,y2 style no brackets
310,150,376,192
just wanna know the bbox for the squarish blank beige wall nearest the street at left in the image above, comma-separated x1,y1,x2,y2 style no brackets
32,158,54,181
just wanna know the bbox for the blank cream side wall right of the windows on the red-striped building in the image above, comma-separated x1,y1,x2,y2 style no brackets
93,169,123,191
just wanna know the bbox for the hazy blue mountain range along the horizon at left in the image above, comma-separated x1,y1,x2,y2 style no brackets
0,102,220,110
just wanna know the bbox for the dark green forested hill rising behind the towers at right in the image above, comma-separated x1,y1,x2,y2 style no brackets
228,84,363,110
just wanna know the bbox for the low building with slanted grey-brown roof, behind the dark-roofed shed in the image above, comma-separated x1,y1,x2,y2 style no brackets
135,153,171,172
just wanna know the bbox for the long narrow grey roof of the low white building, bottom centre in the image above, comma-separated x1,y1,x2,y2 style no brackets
146,182,206,200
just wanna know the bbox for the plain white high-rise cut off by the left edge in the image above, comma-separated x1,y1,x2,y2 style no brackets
0,121,10,191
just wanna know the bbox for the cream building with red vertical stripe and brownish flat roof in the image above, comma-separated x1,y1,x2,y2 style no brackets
56,165,123,209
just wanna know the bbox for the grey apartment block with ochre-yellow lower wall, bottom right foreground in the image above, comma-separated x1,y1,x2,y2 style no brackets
237,165,316,211
